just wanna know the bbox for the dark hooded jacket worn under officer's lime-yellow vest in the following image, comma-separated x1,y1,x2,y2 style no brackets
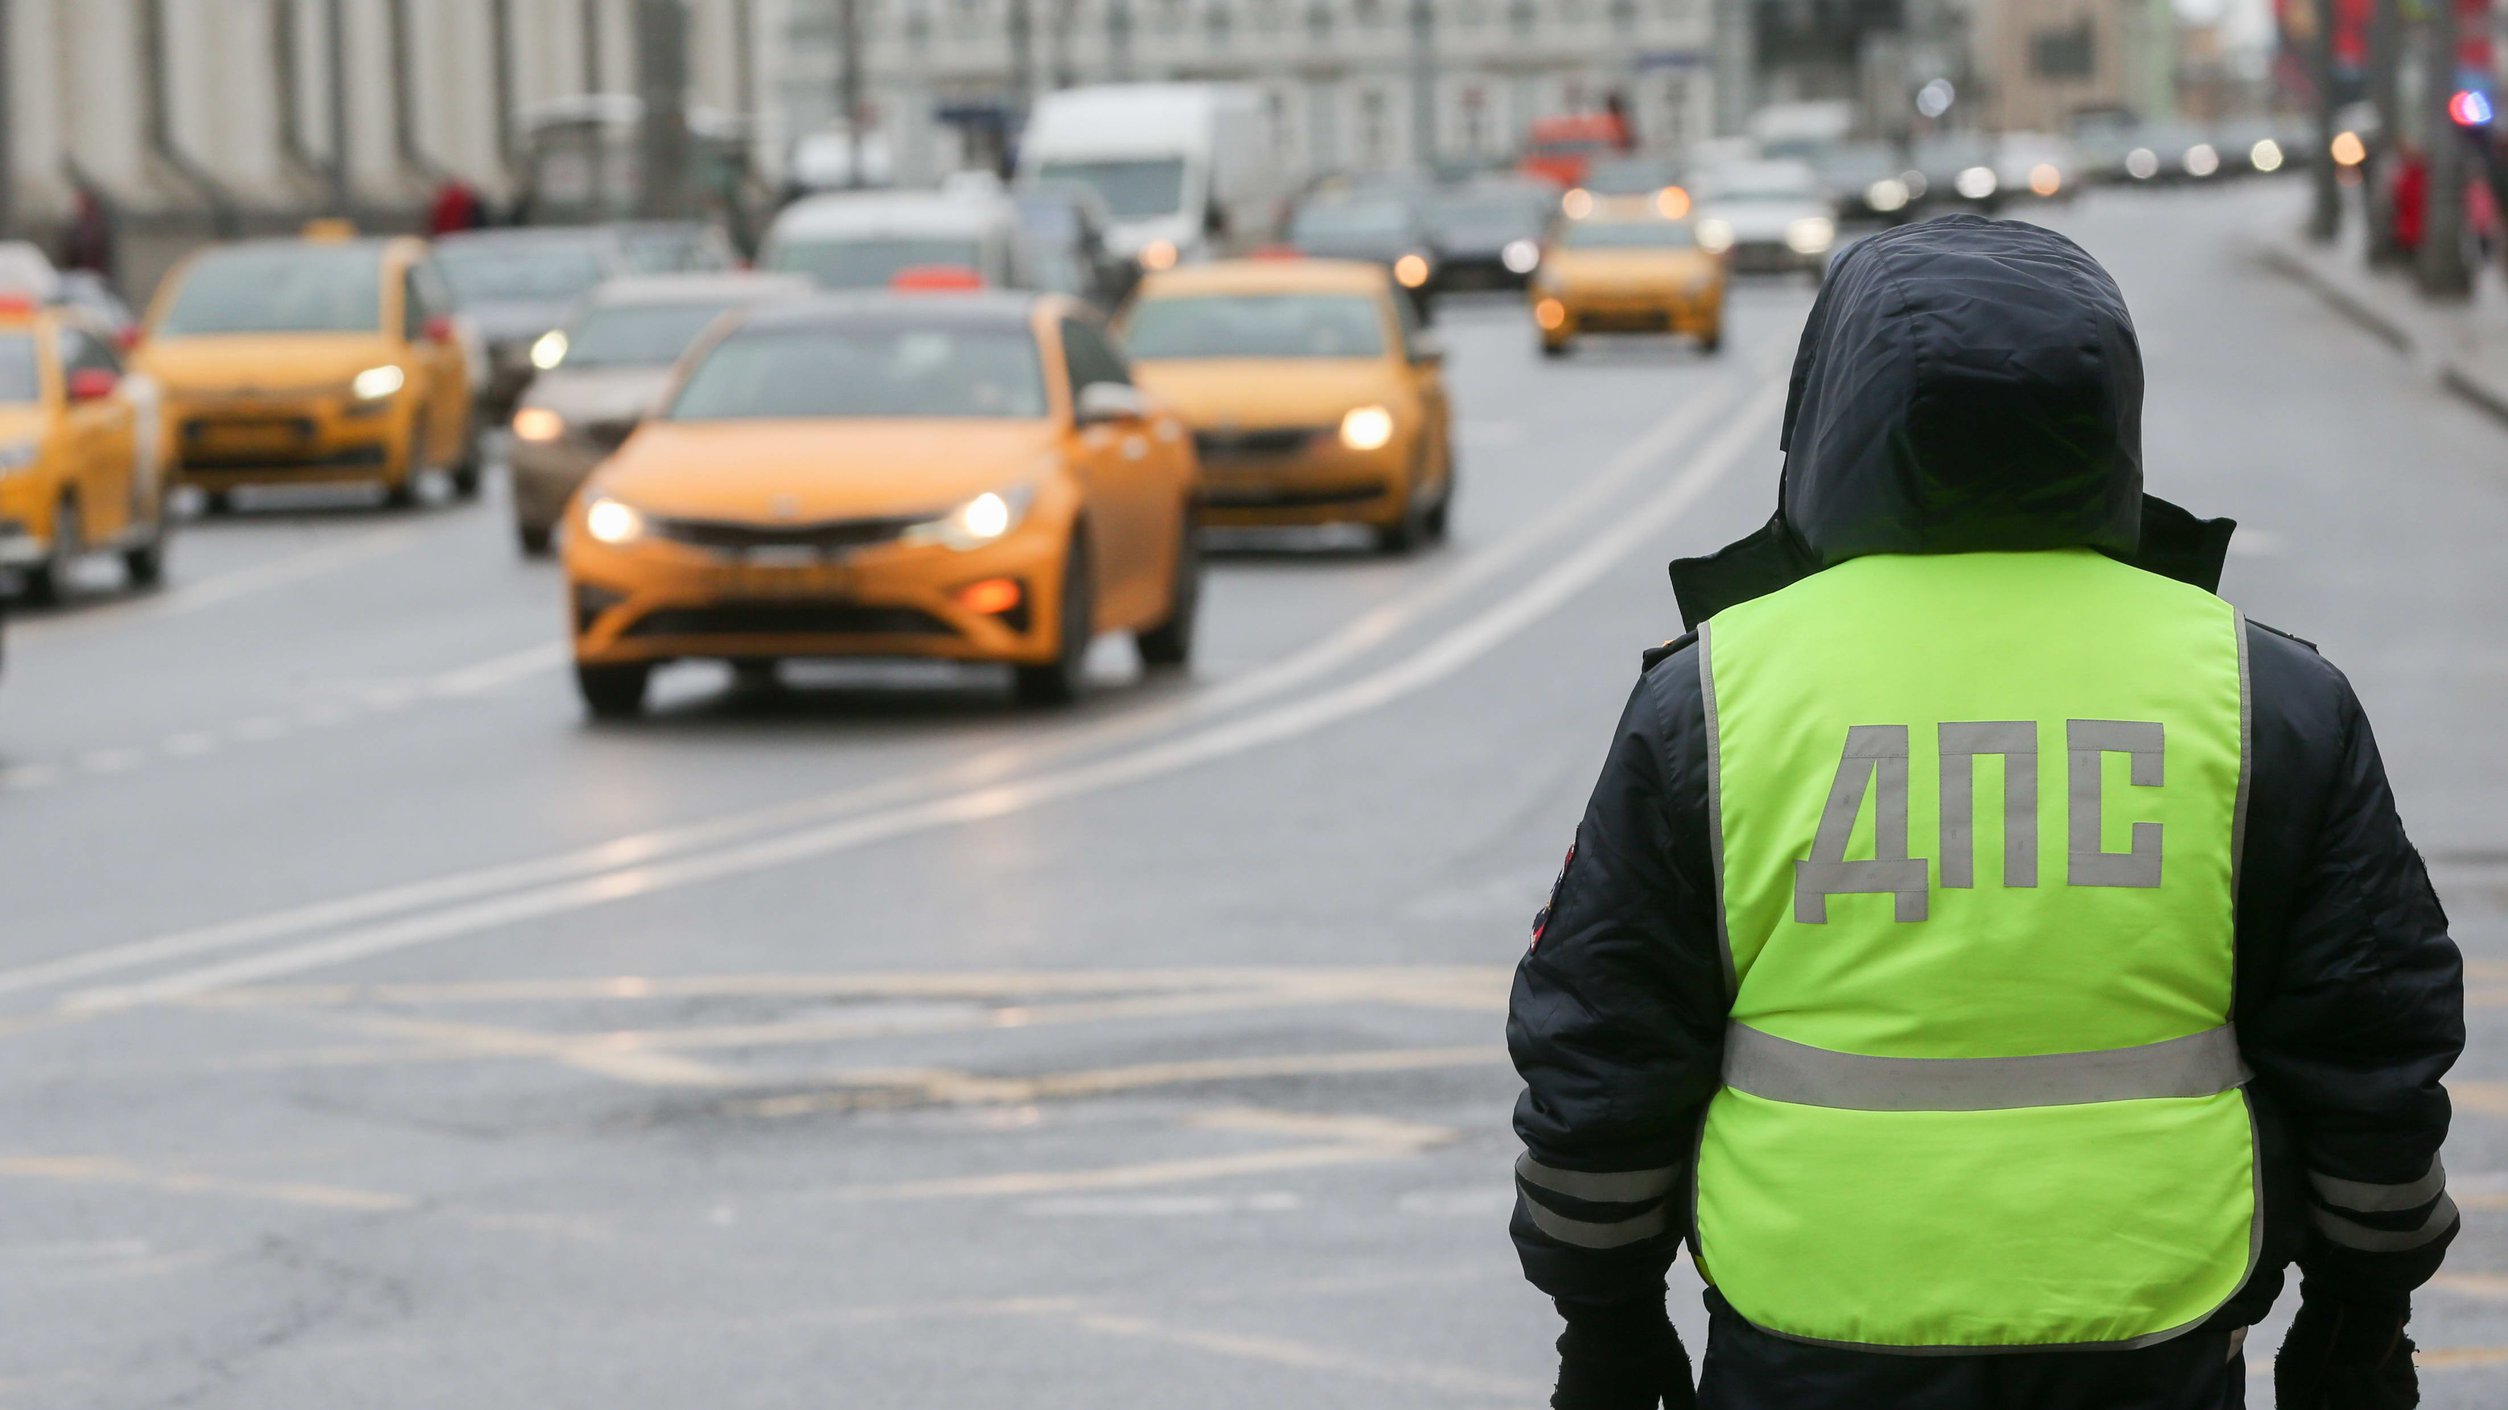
1507,216,2463,1364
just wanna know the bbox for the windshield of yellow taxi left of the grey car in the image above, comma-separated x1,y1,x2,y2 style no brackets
155,243,384,336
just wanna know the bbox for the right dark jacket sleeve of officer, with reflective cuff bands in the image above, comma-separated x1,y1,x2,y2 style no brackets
2237,632,2465,1302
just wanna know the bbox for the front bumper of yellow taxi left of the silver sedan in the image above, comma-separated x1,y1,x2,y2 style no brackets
168,394,411,489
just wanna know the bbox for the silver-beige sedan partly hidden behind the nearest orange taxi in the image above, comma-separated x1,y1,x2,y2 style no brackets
507,273,810,554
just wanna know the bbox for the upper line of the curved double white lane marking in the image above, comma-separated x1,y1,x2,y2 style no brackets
0,369,1773,994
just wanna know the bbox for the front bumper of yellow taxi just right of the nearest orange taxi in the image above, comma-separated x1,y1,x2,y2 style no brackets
1194,427,1412,529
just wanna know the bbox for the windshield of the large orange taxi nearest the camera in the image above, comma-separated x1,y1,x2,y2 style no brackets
670,326,1046,421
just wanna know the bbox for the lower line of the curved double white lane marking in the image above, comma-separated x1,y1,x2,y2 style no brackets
58,386,1783,1011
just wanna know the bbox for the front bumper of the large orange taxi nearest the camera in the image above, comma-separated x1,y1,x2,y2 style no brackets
567,519,1068,665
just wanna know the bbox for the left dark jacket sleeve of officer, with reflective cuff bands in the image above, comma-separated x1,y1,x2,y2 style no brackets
1507,647,1728,1302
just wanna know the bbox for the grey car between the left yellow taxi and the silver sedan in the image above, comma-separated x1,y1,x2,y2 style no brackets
436,226,627,421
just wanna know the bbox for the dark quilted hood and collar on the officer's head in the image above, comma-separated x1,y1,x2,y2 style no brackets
1673,216,2235,625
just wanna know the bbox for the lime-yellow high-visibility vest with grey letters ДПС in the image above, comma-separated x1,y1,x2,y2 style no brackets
1695,549,2260,1350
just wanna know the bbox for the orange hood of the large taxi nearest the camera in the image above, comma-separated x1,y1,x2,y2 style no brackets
592,419,1061,524
